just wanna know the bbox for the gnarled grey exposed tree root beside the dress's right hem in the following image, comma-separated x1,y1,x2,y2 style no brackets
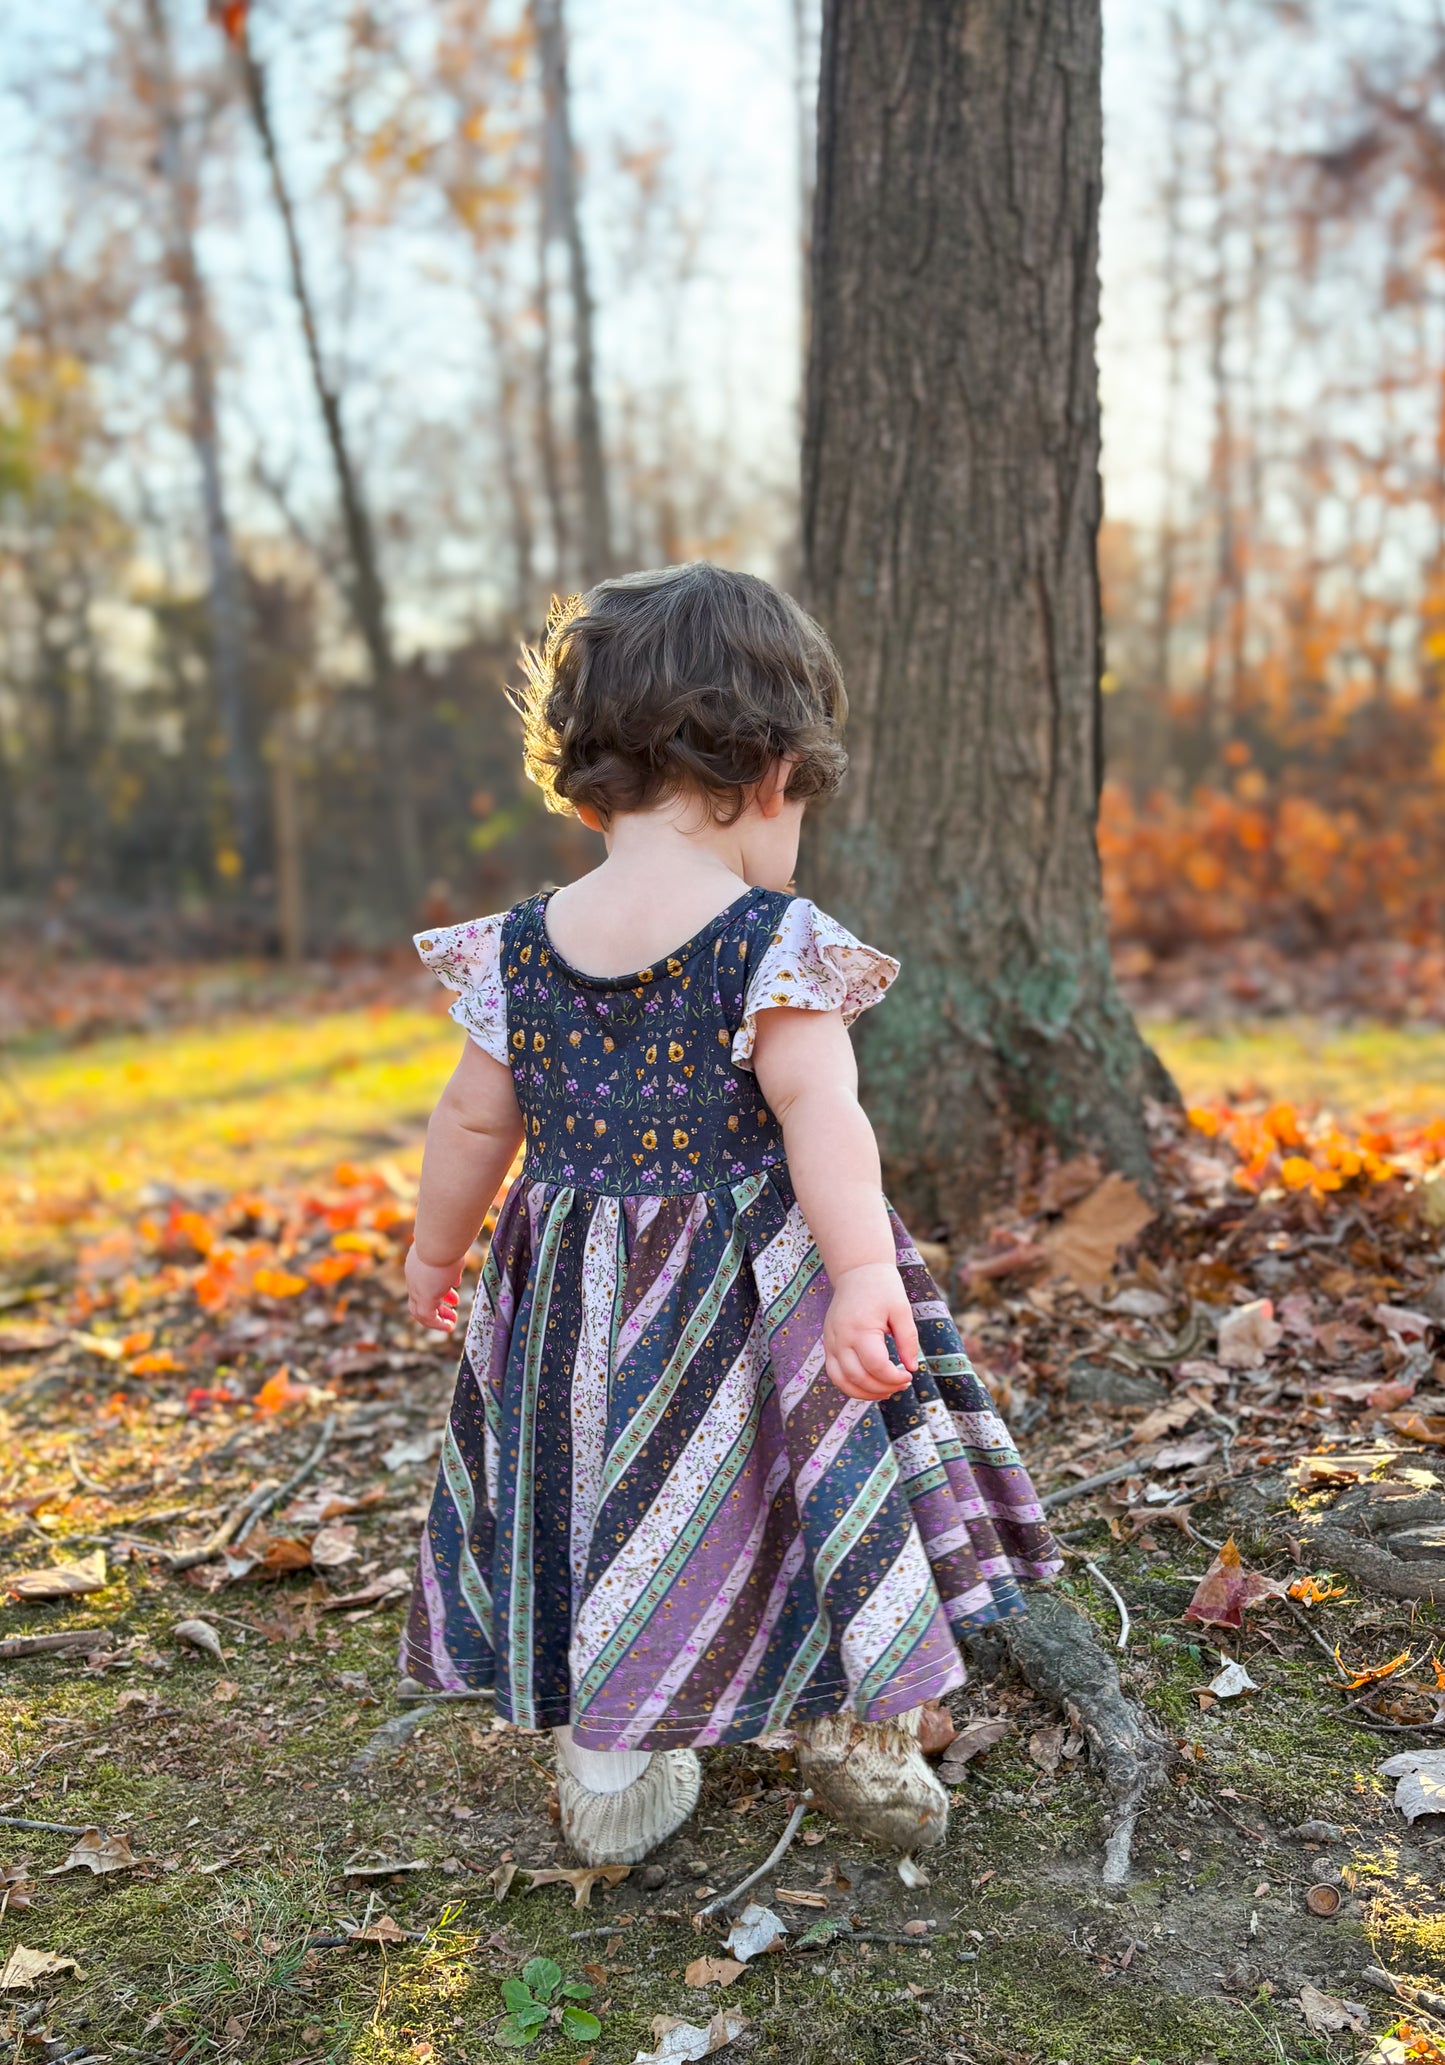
966,1592,1168,1887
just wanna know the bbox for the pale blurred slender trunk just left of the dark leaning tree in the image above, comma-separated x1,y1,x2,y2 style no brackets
145,0,264,882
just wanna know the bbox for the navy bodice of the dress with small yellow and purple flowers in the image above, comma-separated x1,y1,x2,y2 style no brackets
502,890,793,1196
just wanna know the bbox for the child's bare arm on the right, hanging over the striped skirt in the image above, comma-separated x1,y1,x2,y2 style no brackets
753,1010,919,1398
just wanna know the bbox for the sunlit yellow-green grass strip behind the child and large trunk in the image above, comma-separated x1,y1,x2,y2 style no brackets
0,1008,1445,1274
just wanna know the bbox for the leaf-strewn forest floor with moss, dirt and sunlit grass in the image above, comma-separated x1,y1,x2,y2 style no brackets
0,979,1445,2065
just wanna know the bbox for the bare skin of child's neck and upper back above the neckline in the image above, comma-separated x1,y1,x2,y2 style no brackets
547,801,763,975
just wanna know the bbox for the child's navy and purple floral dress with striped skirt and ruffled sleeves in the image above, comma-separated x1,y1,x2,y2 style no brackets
403,890,1059,1749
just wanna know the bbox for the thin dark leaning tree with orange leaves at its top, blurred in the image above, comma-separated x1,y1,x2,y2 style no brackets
219,0,421,911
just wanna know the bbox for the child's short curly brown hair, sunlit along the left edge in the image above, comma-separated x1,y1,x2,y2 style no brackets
510,560,848,824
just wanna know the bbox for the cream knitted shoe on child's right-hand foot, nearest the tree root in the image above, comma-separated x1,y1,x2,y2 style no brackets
793,1708,948,1856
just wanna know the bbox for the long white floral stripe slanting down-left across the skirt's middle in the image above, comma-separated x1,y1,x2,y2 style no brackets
570,1328,768,1685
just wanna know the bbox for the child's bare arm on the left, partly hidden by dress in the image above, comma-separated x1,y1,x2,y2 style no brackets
407,1041,522,1334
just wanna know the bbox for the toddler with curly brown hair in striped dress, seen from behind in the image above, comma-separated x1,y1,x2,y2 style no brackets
403,566,1059,1863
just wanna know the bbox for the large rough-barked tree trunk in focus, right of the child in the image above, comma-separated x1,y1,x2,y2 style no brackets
803,0,1170,1231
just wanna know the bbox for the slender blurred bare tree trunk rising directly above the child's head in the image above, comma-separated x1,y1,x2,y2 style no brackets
533,0,613,586
